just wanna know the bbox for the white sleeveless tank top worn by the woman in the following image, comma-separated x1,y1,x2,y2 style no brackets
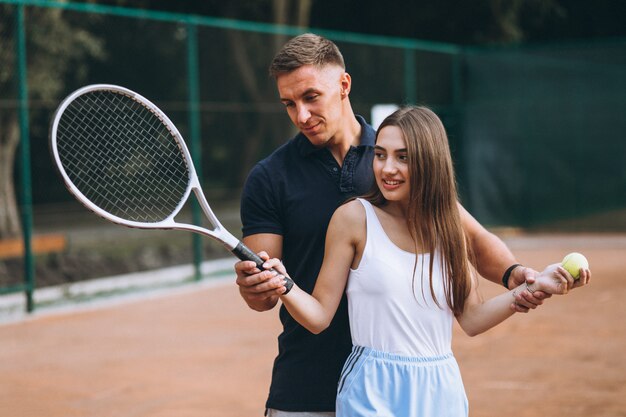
346,199,454,357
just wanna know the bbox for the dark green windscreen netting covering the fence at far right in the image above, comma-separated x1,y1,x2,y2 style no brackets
461,42,626,227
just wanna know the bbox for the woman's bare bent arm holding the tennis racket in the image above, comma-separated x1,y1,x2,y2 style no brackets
264,201,366,334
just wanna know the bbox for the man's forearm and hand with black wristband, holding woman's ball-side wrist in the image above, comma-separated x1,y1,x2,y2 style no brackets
459,204,550,312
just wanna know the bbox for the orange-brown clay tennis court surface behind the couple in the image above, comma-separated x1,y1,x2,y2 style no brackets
0,235,626,417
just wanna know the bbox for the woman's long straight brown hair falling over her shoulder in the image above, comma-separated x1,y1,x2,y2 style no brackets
364,107,471,315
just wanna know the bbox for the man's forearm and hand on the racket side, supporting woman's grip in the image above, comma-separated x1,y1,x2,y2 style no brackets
235,233,285,311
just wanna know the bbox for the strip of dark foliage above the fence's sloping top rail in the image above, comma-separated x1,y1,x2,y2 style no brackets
74,0,626,45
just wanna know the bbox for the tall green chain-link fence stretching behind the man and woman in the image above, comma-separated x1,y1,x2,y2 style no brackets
0,0,626,312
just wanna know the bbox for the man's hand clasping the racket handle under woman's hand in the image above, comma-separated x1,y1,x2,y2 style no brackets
235,252,285,311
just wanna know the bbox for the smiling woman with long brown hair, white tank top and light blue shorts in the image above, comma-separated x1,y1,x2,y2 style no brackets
264,107,590,417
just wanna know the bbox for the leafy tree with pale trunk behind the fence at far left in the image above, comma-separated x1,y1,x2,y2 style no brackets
0,4,105,239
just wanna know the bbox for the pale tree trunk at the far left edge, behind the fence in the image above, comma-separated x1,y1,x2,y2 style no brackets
0,113,21,239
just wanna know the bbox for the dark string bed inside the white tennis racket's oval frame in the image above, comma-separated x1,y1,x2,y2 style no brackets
57,91,190,223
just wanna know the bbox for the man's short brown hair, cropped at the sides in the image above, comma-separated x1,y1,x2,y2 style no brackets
269,33,346,78
